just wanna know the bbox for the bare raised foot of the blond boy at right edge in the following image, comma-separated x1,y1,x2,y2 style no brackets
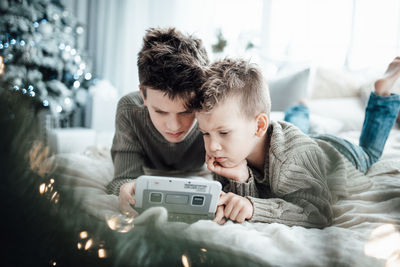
375,57,400,96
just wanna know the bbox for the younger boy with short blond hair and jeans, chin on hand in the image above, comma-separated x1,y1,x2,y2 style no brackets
193,58,400,227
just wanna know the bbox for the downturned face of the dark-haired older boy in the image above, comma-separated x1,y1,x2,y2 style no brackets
143,88,196,143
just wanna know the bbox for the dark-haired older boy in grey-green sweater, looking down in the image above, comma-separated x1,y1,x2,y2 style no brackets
107,28,209,214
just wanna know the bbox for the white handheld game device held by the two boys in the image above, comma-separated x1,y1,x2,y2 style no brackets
133,175,222,219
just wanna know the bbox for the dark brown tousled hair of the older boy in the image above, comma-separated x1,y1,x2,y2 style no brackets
137,28,209,102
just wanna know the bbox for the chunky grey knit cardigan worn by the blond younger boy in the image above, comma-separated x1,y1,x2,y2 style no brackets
216,122,370,228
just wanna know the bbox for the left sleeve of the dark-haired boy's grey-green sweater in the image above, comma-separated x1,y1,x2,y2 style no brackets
107,99,144,196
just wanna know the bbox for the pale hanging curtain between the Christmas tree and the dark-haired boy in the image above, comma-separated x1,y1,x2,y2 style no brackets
67,0,151,96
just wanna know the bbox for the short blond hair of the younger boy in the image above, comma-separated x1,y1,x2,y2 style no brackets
192,58,271,118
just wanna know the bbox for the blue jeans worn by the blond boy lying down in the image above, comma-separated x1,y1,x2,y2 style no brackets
284,92,400,173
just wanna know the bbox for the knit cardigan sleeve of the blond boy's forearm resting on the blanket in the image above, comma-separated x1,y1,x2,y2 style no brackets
248,149,333,228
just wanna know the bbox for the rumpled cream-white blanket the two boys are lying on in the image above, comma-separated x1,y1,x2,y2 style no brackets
56,130,400,267
